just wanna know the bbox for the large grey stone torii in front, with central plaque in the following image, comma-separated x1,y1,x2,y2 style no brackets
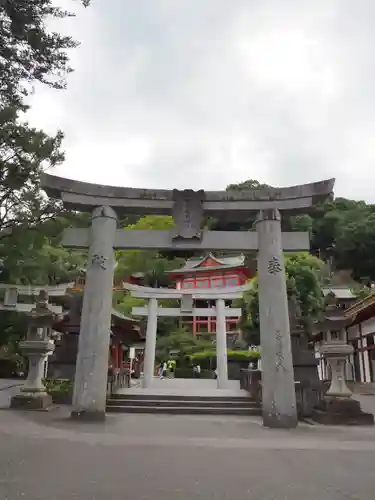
41,174,334,427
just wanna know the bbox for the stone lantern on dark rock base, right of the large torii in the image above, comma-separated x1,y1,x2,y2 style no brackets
314,295,374,425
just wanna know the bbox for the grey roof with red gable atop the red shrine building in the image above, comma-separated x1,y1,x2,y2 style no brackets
168,253,248,276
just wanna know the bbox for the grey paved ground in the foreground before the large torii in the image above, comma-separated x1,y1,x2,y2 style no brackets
0,378,375,500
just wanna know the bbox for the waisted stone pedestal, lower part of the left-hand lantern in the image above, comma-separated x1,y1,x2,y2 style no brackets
10,340,54,410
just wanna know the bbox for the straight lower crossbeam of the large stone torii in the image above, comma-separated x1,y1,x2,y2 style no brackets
63,228,310,252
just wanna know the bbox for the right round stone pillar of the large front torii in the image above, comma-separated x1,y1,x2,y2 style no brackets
256,210,298,428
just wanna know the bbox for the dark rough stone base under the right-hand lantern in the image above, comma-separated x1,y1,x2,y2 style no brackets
311,396,374,425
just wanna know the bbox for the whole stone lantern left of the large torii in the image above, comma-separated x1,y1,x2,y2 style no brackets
11,290,56,410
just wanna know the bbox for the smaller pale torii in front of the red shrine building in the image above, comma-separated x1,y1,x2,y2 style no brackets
124,283,248,389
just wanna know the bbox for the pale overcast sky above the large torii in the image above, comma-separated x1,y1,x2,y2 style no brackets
30,0,375,203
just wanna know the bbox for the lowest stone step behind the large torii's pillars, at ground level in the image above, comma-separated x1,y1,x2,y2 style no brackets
107,404,262,416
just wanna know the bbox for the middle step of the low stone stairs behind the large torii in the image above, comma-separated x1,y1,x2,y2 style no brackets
107,397,259,408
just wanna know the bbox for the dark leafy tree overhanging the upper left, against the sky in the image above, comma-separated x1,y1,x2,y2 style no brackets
0,0,88,238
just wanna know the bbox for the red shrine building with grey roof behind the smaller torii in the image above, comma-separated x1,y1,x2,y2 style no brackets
168,253,253,335
